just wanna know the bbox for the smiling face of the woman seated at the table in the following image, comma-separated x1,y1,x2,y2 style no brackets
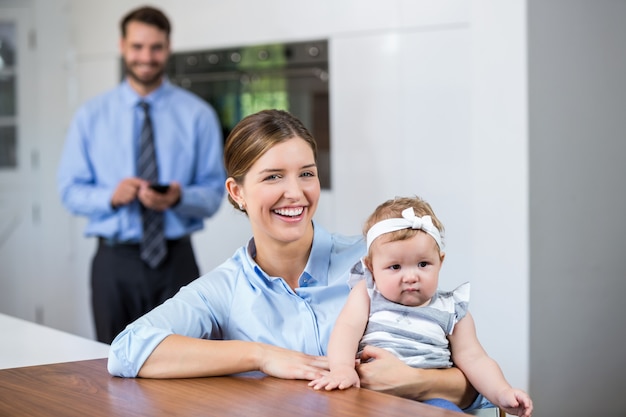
227,137,320,247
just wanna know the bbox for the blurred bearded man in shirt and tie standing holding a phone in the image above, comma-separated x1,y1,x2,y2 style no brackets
58,7,225,343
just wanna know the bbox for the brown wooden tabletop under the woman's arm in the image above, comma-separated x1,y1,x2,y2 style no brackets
0,359,463,417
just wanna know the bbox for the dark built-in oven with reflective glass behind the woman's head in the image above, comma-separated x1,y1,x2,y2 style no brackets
167,40,331,189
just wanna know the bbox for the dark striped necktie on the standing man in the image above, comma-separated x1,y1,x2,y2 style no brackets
137,101,167,268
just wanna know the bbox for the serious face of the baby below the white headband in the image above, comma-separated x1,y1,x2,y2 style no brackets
368,232,443,307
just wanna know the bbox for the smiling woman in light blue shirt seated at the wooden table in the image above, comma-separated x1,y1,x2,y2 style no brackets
108,110,476,406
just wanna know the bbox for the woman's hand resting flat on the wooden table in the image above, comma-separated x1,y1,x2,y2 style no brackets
258,344,328,381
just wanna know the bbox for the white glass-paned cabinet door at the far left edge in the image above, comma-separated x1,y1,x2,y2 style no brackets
0,5,43,320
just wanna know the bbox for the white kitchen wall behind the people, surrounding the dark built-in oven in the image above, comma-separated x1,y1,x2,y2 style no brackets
0,0,529,402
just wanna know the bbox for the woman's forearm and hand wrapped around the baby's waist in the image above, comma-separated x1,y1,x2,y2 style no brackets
357,346,477,408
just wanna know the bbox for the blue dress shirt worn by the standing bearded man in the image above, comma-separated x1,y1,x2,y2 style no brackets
57,80,225,242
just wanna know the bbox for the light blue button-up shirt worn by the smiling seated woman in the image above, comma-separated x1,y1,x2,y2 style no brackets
108,224,365,377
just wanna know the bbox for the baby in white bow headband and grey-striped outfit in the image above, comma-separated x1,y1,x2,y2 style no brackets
309,197,533,417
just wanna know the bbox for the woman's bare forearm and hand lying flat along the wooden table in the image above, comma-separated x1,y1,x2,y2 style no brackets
138,335,328,380
